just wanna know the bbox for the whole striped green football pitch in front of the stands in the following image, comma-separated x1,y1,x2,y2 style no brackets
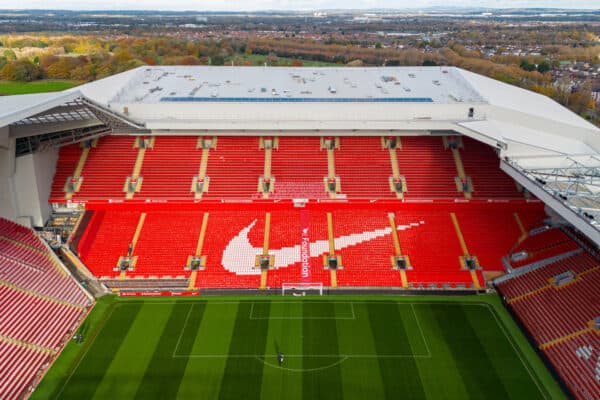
32,296,564,399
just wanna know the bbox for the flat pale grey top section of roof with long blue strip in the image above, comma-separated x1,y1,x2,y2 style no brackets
109,66,484,104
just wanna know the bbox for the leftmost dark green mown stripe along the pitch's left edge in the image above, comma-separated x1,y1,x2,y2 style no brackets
57,303,142,399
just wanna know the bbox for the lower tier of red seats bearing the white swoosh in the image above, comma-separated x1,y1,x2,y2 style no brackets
78,205,540,288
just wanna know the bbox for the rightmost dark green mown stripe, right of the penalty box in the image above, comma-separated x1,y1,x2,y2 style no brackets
434,304,510,399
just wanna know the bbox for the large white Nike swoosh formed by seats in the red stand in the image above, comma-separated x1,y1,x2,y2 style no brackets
221,220,423,275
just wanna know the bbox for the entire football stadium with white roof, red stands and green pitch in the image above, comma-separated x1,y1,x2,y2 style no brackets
0,66,600,400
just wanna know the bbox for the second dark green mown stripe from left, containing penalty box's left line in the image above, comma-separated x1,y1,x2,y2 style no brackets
135,303,205,400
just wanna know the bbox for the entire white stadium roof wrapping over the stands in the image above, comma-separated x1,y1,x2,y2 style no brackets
0,66,600,243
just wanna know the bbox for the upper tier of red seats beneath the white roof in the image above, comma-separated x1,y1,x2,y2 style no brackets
50,136,523,202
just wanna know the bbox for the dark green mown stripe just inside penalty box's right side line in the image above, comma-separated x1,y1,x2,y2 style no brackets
368,302,426,399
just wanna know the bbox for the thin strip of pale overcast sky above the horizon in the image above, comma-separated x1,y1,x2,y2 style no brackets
0,0,600,11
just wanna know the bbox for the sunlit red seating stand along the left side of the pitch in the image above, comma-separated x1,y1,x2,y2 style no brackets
0,218,91,400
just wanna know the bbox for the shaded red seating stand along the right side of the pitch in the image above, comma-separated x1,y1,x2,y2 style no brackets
496,228,600,399
